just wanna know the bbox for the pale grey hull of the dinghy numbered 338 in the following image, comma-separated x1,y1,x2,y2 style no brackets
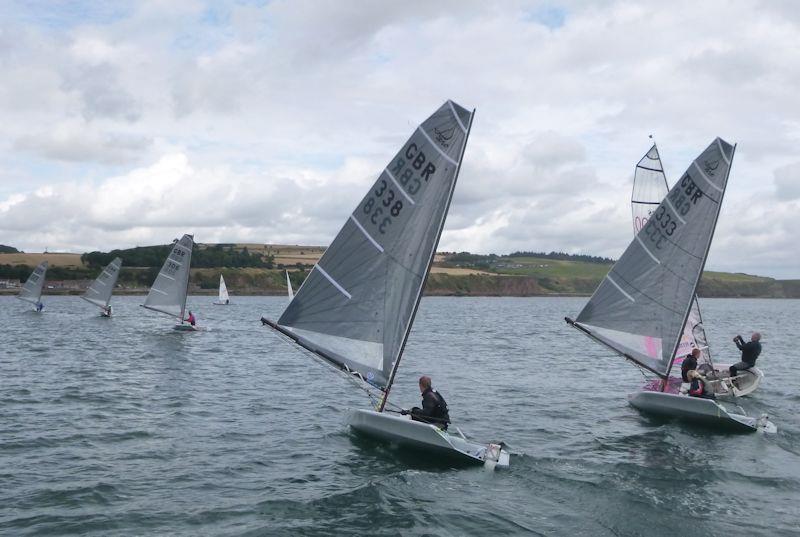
349,410,509,467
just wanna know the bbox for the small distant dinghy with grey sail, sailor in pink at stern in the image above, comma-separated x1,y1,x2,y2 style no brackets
142,235,199,332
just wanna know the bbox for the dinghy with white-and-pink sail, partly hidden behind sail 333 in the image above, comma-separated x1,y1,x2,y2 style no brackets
631,143,764,397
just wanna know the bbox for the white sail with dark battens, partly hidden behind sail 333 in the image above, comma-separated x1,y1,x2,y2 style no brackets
631,143,713,365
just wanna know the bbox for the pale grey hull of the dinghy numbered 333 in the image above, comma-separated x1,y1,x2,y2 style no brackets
628,390,777,432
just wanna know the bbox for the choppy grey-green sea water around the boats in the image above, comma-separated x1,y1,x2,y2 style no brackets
0,297,800,536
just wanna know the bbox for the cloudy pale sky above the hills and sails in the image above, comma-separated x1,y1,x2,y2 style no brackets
0,0,800,278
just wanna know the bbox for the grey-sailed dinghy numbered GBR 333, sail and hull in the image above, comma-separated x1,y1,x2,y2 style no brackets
566,138,777,432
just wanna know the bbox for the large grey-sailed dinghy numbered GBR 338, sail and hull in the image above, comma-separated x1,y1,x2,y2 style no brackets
262,101,509,468
